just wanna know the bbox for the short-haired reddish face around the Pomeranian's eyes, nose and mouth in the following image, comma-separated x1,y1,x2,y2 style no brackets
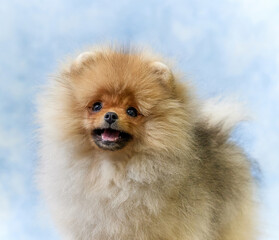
85,93,144,151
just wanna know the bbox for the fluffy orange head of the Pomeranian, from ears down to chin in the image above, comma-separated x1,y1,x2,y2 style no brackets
65,49,184,151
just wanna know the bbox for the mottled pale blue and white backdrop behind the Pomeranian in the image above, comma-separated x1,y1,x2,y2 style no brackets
0,0,279,240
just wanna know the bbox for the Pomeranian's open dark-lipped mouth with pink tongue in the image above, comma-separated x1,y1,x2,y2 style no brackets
92,128,132,151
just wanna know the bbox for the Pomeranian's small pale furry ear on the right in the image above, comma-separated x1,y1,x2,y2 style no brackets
151,61,174,88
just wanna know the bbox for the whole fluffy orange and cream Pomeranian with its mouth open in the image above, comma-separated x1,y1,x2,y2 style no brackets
38,48,256,240
